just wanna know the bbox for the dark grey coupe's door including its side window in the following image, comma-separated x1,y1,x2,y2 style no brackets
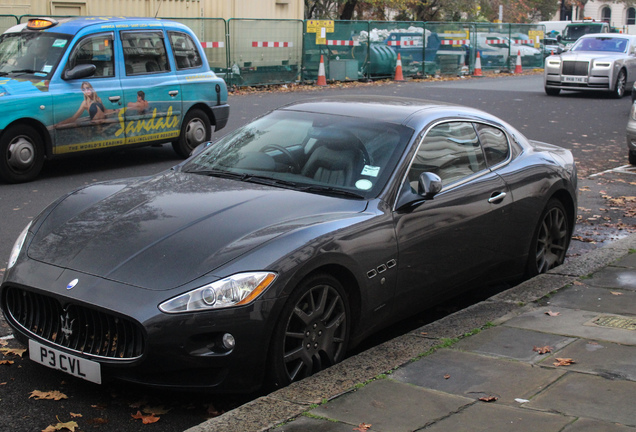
394,121,514,310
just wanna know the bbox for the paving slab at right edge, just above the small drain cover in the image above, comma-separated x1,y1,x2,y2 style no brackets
540,281,636,315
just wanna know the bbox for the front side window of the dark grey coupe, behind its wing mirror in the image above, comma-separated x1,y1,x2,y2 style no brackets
409,122,486,189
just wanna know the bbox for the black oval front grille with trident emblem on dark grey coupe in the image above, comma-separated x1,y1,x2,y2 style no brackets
5,287,144,360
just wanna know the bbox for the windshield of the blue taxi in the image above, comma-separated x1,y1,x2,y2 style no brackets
0,32,70,78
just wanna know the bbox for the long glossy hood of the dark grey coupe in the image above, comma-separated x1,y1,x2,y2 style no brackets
28,172,367,290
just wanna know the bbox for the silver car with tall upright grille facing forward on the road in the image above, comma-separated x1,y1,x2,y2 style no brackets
544,33,636,98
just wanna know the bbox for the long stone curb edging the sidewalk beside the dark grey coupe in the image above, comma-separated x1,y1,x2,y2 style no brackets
185,234,636,432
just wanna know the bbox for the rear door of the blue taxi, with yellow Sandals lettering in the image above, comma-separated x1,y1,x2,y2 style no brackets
120,30,182,144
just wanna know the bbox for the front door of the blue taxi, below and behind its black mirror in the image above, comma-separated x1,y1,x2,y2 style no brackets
50,32,124,154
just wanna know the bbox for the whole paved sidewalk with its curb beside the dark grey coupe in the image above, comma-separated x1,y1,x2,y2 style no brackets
187,235,636,432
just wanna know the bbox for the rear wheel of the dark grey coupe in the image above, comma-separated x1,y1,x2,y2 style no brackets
527,199,572,277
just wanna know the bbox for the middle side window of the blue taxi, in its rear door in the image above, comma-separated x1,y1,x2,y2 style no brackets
121,31,170,75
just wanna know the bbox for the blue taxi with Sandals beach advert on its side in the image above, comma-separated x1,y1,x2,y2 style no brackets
0,17,230,183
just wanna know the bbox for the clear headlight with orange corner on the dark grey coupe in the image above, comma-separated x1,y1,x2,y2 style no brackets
159,272,276,313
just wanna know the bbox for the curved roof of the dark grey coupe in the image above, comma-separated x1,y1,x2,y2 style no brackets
280,95,502,126
